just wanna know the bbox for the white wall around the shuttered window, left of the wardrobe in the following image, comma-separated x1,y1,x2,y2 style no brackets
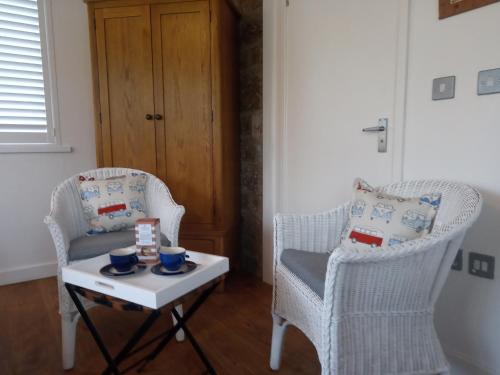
0,0,96,285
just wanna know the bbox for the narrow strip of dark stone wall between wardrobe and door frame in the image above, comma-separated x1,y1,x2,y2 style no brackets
234,0,262,276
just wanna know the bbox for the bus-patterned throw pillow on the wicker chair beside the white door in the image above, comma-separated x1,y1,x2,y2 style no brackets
341,179,441,250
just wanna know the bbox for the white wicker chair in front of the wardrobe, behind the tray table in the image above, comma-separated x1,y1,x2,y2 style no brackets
45,168,184,369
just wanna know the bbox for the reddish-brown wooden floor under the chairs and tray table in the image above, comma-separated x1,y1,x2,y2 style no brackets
0,276,320,375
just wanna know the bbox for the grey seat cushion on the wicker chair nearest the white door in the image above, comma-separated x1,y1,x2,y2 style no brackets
281,249,330,299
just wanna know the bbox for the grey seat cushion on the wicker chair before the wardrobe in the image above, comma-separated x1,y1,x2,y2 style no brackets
68,230,170,261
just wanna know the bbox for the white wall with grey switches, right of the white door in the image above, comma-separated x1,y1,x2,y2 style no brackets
404,0,500,374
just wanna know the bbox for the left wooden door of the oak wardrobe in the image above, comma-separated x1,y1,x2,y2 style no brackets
95,6,156,174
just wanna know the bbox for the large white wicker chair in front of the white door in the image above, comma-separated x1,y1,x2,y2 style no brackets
270,180,482,375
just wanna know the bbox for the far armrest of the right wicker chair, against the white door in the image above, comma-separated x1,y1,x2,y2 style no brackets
274,203,349,264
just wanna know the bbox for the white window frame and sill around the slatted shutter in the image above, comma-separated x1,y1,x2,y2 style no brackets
0,0,72,153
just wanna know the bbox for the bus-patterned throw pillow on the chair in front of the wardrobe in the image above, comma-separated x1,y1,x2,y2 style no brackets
79,173,147,234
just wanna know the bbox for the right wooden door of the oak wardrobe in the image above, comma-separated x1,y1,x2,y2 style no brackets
151,1,214,228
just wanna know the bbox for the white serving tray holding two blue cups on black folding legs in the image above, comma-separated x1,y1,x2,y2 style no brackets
62,251,229,309
